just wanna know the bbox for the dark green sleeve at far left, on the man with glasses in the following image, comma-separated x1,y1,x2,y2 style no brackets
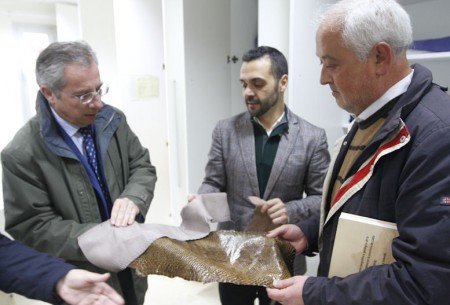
1,141,97,262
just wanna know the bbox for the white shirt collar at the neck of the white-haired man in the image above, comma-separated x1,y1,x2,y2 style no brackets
355,70,414,122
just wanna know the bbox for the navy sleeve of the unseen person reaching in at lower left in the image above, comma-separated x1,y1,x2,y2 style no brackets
0,234,75,304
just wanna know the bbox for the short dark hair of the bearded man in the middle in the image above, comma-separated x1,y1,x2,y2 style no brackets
242,46,288,80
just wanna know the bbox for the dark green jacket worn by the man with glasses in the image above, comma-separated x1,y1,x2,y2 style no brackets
1,93,156,304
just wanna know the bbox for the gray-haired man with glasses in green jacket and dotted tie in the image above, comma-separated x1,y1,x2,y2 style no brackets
1,42,156,305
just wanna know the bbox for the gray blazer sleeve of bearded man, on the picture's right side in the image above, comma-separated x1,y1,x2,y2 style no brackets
286,129,330,225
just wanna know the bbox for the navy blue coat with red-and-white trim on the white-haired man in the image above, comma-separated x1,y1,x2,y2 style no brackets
300,65,450,305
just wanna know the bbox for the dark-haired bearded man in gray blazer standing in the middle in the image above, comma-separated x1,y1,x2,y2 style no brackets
191,46,330,305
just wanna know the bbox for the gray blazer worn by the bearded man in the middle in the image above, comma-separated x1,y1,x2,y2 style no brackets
198,107,330,231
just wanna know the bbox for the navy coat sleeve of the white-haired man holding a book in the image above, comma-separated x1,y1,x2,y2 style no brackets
303,114,450,305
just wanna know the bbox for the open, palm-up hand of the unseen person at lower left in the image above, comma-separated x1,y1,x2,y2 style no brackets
56,269,125,305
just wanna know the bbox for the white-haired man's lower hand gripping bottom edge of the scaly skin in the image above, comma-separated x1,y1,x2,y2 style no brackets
267,276,308,305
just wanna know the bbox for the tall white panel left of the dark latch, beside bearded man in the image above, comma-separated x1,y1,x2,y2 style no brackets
184,0,231,192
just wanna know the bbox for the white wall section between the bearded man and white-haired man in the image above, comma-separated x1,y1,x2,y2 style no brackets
258,0,348,150
